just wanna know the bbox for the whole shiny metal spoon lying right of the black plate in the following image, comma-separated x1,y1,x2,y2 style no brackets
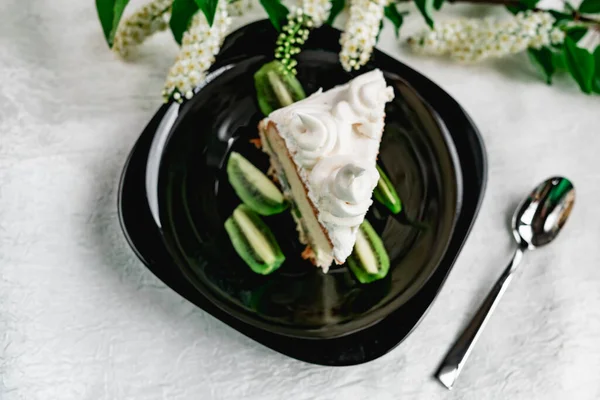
436,177,575,389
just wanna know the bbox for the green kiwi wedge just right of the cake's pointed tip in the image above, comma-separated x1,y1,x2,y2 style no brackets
348,220,390,283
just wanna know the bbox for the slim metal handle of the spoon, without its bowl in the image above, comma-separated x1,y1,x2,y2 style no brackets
436,248,523,389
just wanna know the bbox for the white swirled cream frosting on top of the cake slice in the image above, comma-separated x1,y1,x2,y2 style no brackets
268,70,394,262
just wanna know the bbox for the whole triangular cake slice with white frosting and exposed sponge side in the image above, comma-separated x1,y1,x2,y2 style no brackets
259,70,394,272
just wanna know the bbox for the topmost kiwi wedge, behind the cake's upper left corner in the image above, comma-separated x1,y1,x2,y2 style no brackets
254,60,306,115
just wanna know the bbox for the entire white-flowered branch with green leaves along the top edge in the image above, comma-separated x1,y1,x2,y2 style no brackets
96,0,600,101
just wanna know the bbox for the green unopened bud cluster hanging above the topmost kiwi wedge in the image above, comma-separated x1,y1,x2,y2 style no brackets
275,8,314,75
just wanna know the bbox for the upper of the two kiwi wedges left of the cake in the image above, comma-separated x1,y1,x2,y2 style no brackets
227,151,288,215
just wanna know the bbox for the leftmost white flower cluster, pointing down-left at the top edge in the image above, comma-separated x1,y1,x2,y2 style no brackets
112,0,173,58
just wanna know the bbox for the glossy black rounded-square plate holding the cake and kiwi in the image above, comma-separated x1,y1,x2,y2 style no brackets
120,21,486,365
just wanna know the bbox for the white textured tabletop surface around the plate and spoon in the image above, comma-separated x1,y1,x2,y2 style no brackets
0,0,600,400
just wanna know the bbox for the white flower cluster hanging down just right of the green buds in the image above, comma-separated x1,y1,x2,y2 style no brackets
340,0,387,71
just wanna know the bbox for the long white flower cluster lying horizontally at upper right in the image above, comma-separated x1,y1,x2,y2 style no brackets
408,11,565,62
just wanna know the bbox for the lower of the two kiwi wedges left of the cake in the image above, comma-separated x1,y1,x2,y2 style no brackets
225,204,285,275
